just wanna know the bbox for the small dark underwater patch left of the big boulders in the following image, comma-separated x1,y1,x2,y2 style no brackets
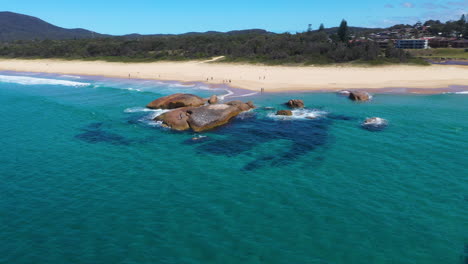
75,123,130,145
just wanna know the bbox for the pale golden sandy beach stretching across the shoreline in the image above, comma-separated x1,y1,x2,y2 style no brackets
0,59,468,92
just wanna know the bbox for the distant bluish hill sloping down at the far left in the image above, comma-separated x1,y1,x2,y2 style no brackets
0,12,107,41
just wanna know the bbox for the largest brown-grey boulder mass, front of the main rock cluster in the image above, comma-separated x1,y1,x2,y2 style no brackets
154,97,255,132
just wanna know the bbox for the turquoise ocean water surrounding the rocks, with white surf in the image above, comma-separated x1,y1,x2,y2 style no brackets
0,72,468,264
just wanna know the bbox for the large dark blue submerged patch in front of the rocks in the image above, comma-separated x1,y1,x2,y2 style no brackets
197,117,332,171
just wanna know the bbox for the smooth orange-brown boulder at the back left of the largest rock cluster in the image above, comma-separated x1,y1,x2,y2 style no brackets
146,93,205,109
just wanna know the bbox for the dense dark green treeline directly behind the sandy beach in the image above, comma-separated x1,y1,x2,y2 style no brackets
0,20,409,64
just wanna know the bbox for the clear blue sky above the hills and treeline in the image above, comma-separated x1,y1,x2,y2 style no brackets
0,0,468,35
